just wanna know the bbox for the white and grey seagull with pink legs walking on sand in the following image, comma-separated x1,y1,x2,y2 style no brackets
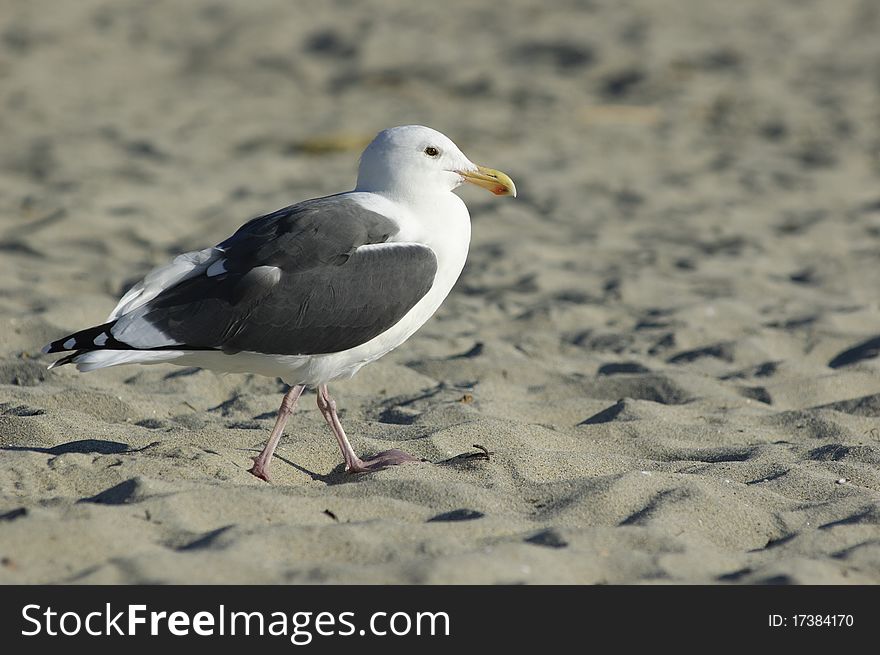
43,125,516,481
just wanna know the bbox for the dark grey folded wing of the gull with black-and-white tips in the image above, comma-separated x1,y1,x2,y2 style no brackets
51,196,437,355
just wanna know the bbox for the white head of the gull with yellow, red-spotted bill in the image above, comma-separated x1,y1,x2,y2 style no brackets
357,125,516,197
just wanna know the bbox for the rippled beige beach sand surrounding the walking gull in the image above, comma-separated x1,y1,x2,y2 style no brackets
0,0,880,584
